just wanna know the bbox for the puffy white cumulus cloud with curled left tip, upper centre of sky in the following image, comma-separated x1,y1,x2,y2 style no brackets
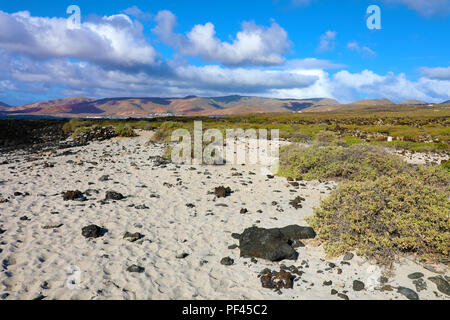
152,10,291,66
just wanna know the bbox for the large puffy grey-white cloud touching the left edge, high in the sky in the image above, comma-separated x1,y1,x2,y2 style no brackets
0,11,157,67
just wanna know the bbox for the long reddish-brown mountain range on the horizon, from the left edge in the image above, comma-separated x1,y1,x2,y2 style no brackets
2,96,339,118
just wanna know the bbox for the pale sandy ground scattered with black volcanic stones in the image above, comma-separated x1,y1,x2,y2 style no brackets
0,133,449,300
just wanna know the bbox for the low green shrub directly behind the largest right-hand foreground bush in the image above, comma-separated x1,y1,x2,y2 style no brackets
279,144,407,181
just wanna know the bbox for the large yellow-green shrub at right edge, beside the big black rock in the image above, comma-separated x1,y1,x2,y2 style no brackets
307,173,450,262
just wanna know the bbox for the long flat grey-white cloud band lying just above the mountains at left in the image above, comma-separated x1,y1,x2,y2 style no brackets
0,48,318,102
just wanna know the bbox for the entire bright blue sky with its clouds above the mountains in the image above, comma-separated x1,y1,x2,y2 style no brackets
0,0,450,105
